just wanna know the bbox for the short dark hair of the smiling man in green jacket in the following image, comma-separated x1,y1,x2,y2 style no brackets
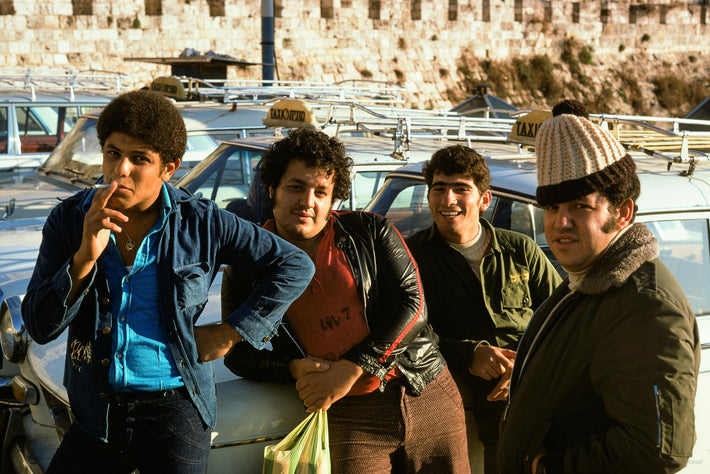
422,145,491,194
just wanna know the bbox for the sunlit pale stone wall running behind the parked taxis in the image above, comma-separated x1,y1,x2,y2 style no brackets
0,0,710,108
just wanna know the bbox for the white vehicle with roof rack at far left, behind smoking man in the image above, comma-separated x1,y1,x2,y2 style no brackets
0,68,127,171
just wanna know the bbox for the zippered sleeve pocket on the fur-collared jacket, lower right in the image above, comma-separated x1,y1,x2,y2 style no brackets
653,385,695,458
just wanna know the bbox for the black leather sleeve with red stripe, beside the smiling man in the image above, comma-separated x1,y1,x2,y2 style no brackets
343,215,427,380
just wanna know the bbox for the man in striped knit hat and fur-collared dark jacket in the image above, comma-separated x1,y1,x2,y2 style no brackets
498,114,700,474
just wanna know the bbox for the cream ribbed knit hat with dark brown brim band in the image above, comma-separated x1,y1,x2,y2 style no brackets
535,114,636,206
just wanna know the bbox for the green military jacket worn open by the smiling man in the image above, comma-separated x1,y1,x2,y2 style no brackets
407,219,562,373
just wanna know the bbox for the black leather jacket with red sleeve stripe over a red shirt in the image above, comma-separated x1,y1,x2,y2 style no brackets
222,212,446,395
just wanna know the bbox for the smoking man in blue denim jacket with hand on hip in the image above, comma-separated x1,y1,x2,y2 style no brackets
22,91,313,473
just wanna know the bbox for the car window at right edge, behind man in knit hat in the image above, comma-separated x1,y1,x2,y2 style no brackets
646,219,710,314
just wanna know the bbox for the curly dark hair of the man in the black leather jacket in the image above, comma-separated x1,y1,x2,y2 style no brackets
259,128,353,200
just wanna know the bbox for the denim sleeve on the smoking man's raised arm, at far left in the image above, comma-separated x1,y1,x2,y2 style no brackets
22,198,96,344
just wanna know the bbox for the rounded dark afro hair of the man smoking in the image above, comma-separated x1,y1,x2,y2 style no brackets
96,89,187,165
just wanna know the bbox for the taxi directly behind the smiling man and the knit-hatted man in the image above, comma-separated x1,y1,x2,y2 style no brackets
365,112,710,474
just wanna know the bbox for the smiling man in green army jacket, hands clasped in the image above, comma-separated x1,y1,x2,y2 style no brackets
407,145,561,474
